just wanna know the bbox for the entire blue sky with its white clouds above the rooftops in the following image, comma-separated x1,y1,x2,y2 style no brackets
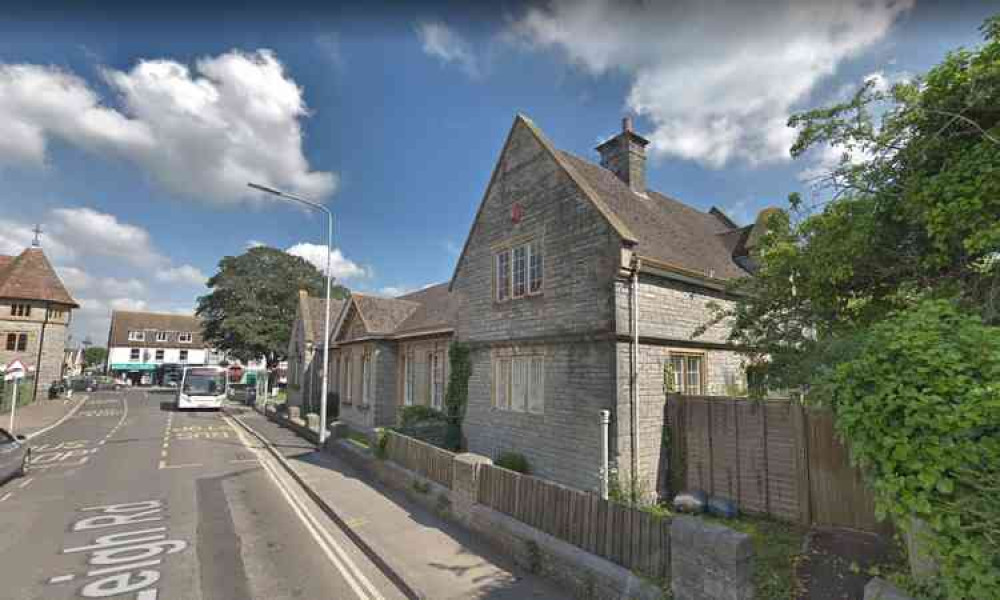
0,0,998,344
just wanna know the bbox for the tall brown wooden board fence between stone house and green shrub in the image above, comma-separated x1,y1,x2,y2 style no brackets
668,395,887,532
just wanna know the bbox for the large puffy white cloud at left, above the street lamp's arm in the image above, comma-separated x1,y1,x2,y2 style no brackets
0,50,337,203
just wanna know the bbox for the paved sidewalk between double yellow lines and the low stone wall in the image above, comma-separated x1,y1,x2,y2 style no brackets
238,410,572,600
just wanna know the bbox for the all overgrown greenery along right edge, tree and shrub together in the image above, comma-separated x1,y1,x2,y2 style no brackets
715,16,1000,600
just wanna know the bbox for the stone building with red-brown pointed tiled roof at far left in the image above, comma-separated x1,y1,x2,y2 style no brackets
0,243,79,399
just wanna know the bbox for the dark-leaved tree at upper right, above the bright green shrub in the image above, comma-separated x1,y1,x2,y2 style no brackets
716,16,1000,386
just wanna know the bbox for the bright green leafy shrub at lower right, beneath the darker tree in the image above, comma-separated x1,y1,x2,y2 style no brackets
824,300,1000,600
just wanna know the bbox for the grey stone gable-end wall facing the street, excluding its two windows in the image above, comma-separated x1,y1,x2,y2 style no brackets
453,116,621,489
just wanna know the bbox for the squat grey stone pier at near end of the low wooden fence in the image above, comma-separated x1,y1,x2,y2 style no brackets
670,516,752,600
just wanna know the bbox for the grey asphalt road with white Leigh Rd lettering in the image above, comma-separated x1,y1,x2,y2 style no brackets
0,390,403,600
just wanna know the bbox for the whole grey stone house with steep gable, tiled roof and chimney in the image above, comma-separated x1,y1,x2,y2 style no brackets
302,115,763,494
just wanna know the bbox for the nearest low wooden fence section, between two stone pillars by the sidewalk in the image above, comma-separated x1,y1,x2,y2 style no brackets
478,466,670,578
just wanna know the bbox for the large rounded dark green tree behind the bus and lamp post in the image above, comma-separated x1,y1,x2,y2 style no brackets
196,246,350,368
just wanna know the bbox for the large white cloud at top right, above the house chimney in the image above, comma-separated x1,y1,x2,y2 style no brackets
507,0,913,168
